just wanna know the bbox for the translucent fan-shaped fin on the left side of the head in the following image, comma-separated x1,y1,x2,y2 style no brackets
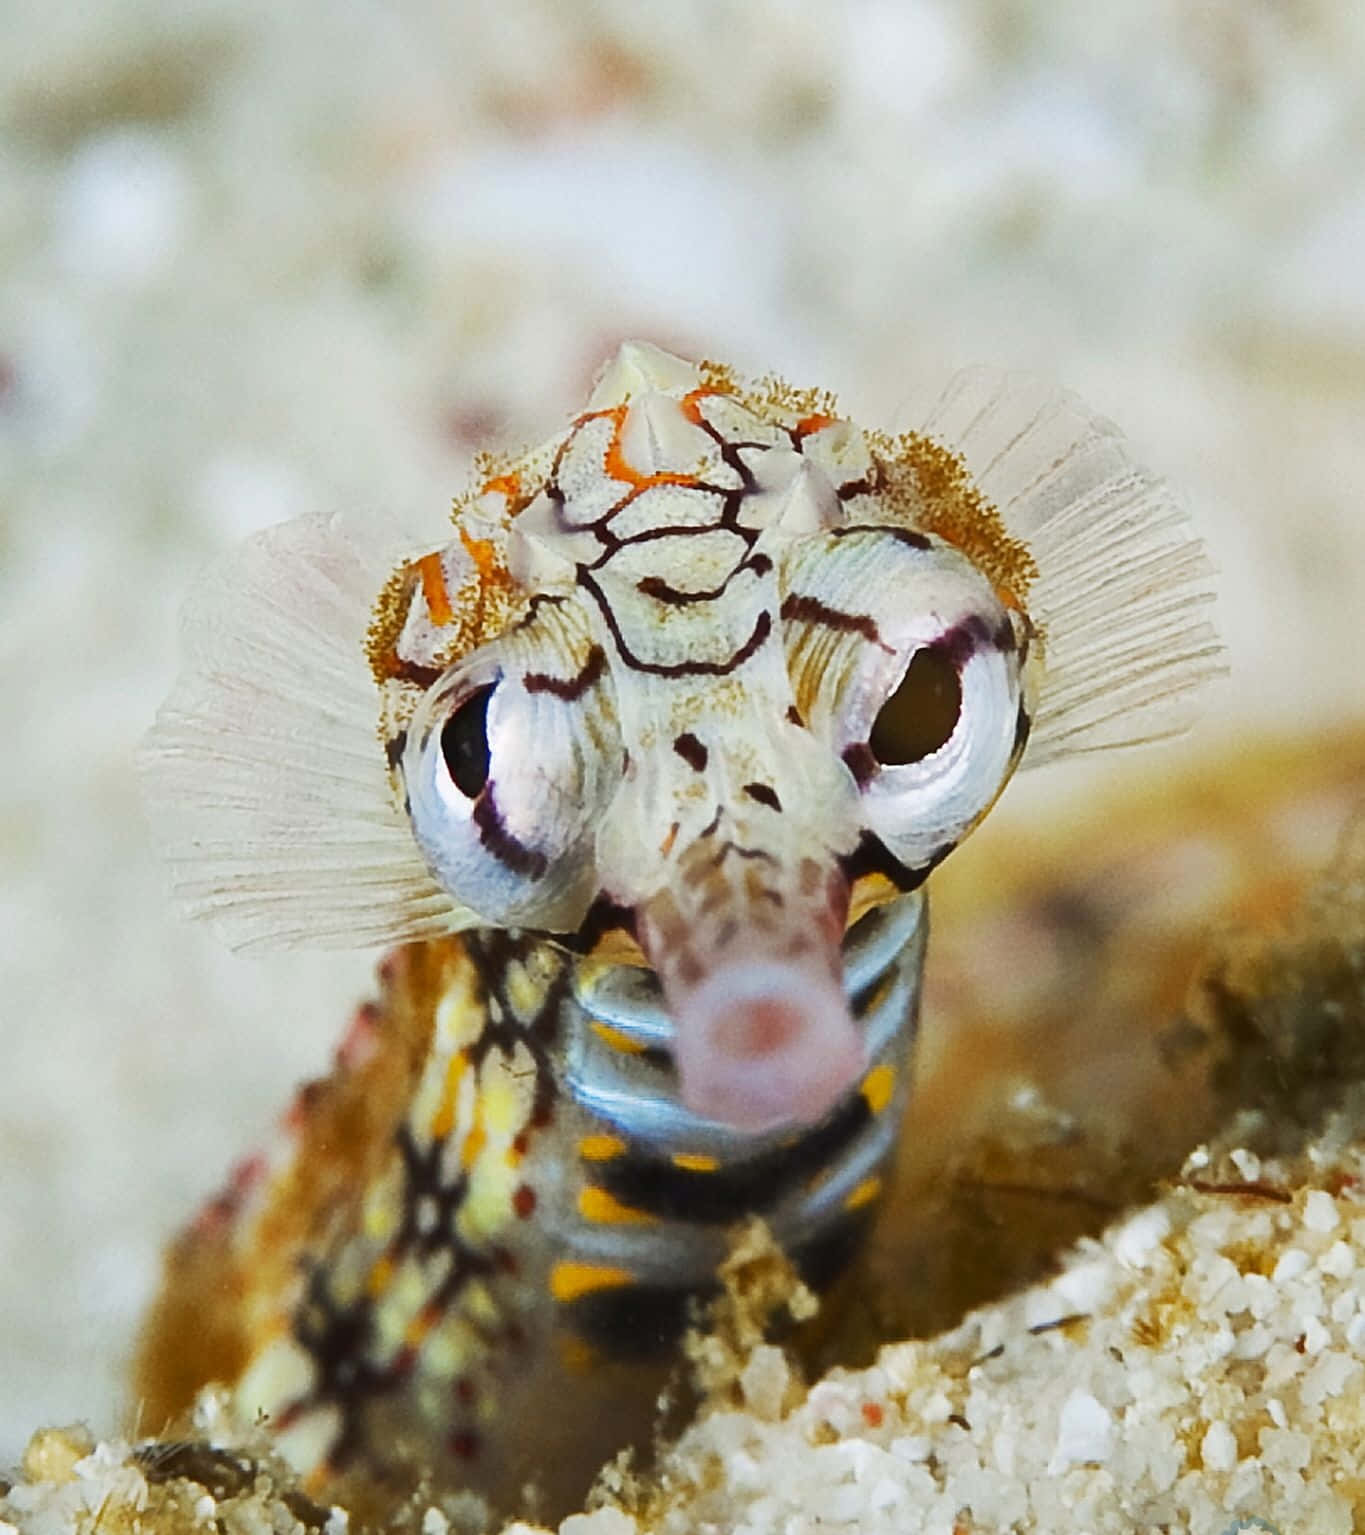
140,516,473,947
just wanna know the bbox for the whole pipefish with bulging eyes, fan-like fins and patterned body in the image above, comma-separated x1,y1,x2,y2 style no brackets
140,345,1218,1503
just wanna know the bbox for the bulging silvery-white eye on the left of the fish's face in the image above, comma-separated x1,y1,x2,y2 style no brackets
402,631,620,932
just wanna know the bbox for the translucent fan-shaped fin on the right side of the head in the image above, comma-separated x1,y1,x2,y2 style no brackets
920,368,1225,766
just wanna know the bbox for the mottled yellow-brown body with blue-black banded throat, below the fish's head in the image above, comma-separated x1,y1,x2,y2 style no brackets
141,893,924,1503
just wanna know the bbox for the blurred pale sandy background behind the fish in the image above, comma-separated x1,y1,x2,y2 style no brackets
0,0,1365,1463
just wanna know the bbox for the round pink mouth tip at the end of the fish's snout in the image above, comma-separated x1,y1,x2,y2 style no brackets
669,955,866,1131
